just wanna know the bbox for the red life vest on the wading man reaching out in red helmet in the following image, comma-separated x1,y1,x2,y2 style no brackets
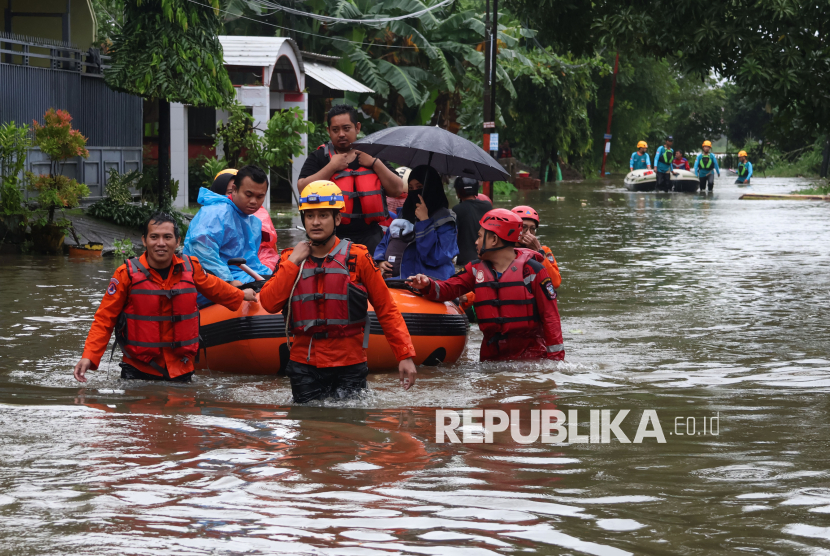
472,249,543,339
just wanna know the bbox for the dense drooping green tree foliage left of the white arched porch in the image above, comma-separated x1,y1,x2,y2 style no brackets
105,0,234,107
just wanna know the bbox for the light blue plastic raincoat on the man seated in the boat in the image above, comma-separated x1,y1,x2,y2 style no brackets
182,187,271,284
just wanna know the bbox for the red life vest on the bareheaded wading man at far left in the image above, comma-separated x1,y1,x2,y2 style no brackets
115,256,199,377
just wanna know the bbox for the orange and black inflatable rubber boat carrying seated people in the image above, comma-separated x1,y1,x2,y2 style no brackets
196,281,470,375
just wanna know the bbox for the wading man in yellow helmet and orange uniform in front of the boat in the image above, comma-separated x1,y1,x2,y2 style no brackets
259,181,416,403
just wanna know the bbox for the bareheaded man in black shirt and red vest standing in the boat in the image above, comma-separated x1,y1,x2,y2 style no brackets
297,104,404,253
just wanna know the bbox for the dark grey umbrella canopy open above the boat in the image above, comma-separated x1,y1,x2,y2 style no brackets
352,125,510,181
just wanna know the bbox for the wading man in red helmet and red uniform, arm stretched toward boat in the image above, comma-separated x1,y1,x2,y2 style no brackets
408,209,565,361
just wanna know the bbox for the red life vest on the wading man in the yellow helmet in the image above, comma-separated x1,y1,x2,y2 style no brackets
290,239,369,349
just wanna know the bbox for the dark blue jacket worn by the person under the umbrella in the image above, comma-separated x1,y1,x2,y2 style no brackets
374,208,458,280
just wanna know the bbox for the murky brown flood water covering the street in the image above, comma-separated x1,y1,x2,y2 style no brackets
0,177,830,556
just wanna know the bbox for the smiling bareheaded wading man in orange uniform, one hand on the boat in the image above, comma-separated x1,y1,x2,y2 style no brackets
74,213,256,382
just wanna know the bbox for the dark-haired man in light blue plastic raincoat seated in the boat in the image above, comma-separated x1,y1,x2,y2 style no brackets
182,166,271,288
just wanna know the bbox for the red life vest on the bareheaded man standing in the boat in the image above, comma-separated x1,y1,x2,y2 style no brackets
319,143,389,224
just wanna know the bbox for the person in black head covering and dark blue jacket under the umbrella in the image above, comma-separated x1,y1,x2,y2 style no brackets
374,165,458,280
